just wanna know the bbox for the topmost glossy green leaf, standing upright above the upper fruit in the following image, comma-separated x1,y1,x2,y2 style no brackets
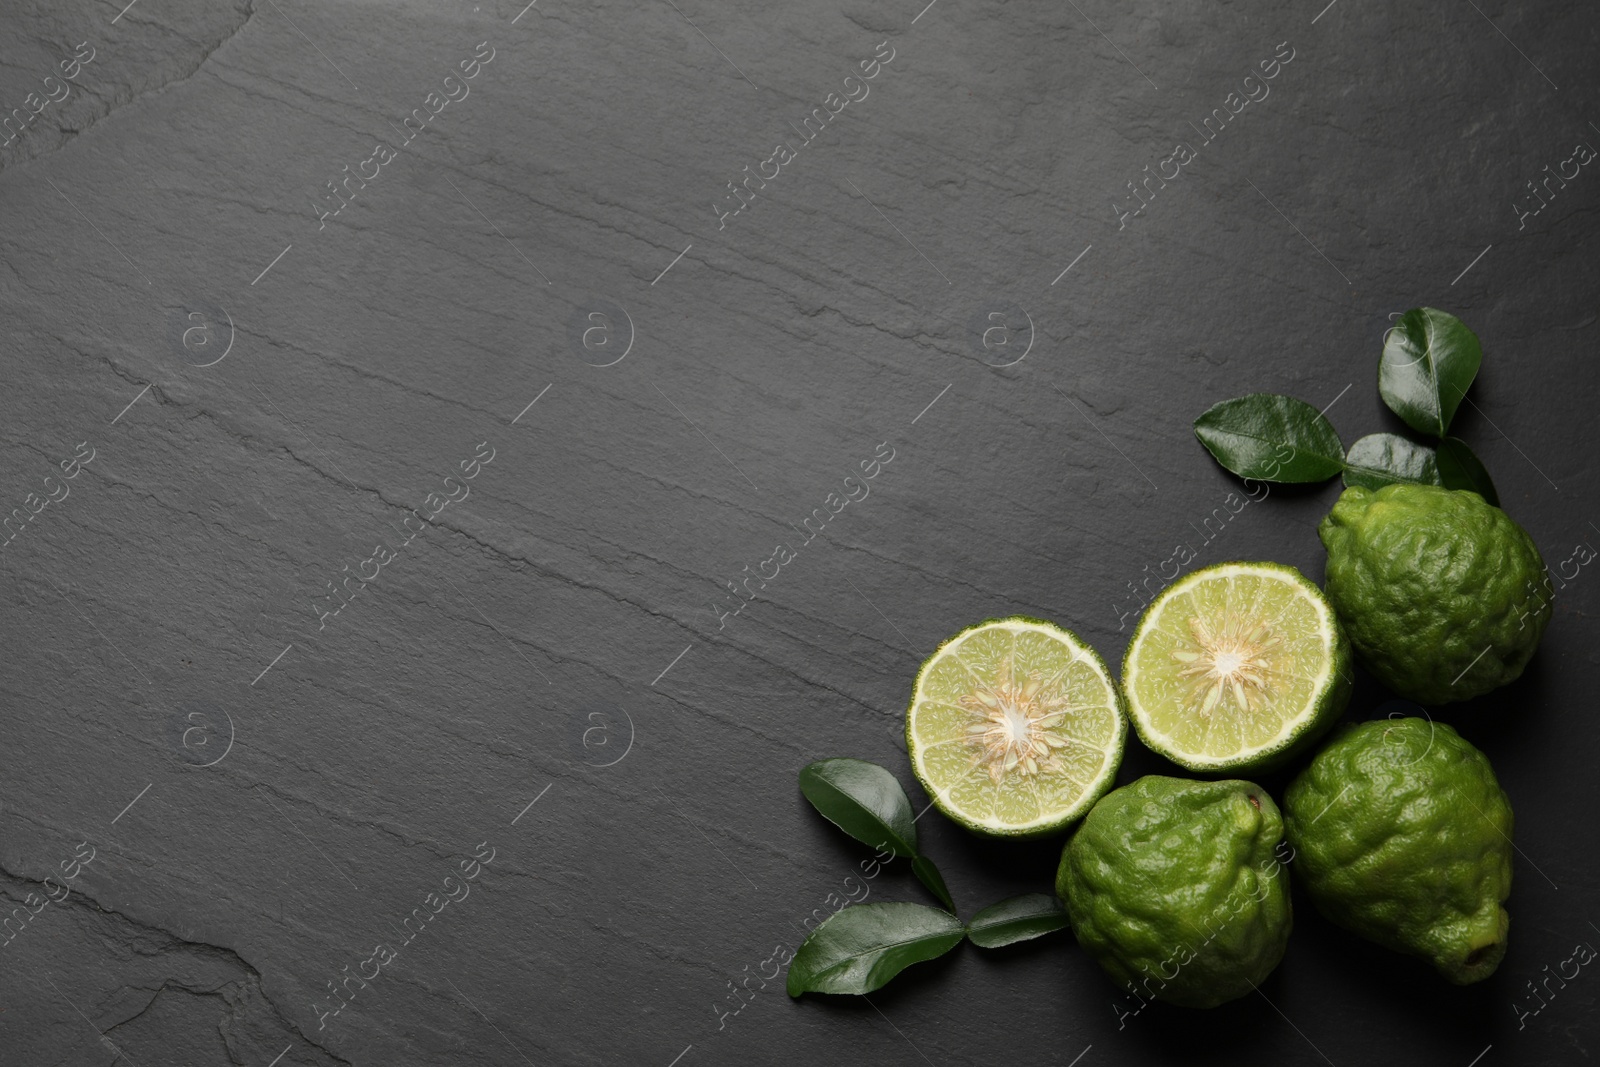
1378,307,1483,437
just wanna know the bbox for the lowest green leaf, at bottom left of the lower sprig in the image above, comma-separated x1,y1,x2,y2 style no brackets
789,904,966,997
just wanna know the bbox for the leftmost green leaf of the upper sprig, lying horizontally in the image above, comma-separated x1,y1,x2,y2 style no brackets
1195,392,1344,482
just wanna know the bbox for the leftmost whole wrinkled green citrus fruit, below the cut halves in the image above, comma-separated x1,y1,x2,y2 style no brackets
1056,774,1293,1008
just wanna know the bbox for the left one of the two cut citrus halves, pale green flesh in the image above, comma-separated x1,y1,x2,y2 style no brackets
906,616,1128,837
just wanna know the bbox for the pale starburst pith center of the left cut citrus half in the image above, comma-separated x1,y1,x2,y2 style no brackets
962,656,1067,784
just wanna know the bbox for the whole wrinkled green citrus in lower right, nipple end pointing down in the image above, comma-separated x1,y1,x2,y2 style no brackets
1283,718,1512,985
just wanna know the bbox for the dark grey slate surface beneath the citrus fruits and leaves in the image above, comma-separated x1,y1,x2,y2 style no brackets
0,0,1600,1067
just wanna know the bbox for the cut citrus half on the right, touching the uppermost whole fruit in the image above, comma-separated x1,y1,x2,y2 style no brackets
1122,563,1352,773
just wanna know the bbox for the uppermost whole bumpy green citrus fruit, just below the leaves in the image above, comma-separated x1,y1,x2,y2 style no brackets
1317,485,1550,704
